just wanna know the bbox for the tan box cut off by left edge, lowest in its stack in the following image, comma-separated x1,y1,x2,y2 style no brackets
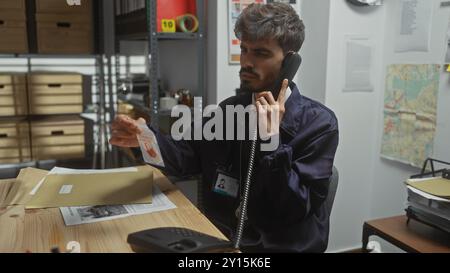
0,119,31,164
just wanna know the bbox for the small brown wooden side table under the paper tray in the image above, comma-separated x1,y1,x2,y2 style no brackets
362,216,450,253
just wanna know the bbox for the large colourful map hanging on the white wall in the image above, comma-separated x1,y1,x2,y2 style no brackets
381,65,440,167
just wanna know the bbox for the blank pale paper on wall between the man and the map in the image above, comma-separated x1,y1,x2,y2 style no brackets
343,36,373,92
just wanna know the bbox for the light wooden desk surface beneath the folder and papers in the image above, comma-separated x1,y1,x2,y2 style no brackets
0,169,226,253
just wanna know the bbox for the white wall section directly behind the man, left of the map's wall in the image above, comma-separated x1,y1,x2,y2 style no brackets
320,0,385,251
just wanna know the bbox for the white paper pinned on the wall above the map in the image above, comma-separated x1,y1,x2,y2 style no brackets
395,0,434,52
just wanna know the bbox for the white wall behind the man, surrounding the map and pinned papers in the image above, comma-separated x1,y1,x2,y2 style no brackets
316,0,450,251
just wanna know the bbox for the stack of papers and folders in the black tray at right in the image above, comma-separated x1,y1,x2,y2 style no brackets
406,177,450,232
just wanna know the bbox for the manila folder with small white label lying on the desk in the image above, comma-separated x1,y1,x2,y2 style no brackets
26,170,153,209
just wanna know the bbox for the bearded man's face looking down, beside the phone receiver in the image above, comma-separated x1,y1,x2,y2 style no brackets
239,39,284,92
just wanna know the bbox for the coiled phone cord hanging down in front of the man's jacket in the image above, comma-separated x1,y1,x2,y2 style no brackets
234,129,257,249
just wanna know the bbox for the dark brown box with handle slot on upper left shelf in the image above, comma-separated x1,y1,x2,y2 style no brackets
36,14,94,54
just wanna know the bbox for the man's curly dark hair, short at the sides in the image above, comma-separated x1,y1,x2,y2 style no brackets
234,3,305,53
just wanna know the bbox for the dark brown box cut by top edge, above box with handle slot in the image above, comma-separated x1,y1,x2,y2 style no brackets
36,0,92,16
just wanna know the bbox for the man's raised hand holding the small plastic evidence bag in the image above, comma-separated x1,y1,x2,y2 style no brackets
109,115,146,148
